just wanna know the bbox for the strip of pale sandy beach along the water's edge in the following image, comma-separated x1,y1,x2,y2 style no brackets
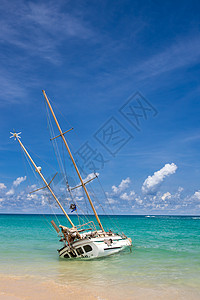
0,274,200,300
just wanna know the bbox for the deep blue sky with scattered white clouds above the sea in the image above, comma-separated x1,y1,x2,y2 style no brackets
0,1,200,214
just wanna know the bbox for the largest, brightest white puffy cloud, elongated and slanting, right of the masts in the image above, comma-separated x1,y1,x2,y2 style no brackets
142,163,177,194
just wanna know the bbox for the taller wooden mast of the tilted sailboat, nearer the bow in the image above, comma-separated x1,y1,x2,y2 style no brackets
42,90,104,231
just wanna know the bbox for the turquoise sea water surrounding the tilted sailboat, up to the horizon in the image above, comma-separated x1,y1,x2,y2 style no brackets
0,215,200,295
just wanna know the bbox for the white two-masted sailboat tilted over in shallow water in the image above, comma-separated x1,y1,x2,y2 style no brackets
11,91,132,258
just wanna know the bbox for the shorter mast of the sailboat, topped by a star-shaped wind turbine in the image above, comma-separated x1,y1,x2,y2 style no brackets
13,133,74,227
